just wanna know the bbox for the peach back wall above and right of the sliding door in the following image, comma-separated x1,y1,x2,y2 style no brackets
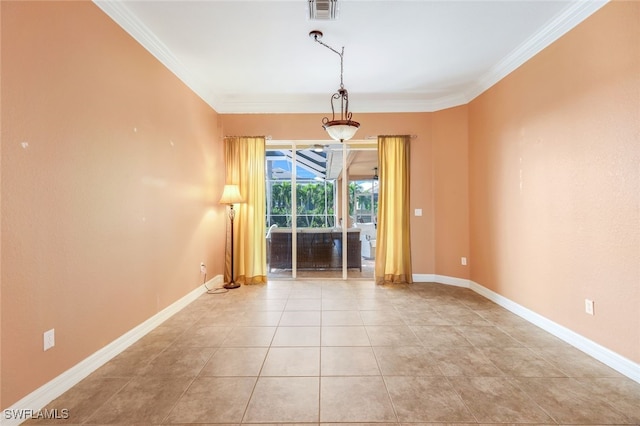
221,111,468,278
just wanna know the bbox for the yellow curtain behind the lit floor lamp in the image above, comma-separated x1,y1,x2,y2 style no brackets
225,137,267,284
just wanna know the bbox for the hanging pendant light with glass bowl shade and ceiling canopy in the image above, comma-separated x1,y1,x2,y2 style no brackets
309,30,360,142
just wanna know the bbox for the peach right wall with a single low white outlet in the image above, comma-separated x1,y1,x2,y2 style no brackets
469,2,640,362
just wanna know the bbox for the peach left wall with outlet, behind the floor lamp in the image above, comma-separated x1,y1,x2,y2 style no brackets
0,1,226,408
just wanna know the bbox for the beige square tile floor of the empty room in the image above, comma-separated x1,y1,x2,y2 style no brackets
29,281,640,425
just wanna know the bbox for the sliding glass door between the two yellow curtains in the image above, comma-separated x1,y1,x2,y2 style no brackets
266,141,377,279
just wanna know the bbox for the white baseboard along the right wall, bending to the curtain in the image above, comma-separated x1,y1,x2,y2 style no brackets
413,274,640,383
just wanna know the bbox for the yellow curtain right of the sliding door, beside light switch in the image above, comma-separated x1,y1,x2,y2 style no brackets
375,136,413,284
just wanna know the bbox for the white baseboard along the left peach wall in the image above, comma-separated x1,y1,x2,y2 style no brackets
0,275,223,426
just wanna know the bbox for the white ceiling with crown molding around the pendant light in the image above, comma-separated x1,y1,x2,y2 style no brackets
95,0,606,113
